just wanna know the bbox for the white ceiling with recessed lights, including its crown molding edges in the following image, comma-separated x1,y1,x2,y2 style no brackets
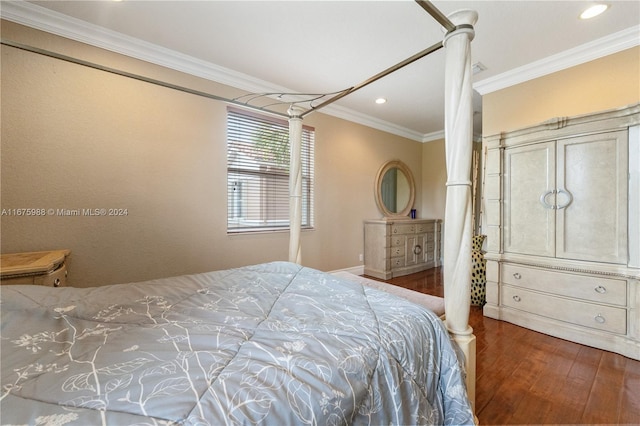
1,0,640,141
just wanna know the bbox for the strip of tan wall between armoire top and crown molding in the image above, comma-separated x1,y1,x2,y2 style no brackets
482,47,640,136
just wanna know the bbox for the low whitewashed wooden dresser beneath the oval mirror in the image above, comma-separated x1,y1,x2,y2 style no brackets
364,219,441,280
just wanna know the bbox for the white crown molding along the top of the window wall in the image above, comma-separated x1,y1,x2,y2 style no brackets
0,1,425,142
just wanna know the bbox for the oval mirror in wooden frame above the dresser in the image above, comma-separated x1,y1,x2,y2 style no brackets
375,160,415,217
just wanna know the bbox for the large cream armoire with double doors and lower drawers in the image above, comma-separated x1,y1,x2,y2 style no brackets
482,105,640,359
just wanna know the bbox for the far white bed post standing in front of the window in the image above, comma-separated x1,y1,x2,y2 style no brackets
287,105,302,264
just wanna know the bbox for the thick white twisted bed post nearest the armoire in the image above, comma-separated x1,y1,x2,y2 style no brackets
443,10,478,412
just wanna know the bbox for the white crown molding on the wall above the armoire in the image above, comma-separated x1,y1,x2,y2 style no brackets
473,25,640,95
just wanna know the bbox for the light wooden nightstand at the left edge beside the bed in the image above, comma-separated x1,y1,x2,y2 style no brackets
0,250,71,287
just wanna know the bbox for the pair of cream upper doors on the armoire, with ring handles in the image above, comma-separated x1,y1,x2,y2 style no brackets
503,130,628,264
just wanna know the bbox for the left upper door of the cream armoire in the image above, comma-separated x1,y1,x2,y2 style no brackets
503,142,556,257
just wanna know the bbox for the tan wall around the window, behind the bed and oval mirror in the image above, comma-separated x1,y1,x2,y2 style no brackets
0,21,432,287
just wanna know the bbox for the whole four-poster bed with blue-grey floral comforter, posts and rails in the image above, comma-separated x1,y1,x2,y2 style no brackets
2,0,477,424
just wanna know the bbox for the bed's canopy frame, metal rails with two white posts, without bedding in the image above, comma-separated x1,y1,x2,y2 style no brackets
2,0,478,409
